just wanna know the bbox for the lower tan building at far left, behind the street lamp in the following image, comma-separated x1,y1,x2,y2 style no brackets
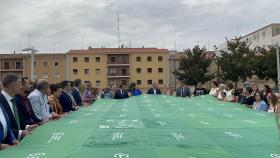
0,54,66,83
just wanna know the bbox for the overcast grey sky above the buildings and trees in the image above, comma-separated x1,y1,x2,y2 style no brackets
0,0,280,53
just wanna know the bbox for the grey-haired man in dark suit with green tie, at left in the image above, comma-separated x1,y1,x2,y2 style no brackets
0,73,30,140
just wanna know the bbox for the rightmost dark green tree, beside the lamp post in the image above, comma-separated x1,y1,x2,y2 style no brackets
254,47,278,87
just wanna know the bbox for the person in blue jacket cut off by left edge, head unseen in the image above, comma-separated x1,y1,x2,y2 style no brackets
0,103,19,150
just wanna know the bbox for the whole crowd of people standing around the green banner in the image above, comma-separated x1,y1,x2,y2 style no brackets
0,73,279,150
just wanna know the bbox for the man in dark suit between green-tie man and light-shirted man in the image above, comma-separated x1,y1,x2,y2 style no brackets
14,79,44,128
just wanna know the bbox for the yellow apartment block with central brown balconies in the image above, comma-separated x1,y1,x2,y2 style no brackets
66,48,168,89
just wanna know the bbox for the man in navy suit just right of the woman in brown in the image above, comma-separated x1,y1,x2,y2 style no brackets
59,81,75,113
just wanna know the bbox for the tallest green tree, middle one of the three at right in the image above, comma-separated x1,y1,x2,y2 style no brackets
217,37,254,84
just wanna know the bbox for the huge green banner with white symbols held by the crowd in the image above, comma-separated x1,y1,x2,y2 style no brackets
0,95,280,158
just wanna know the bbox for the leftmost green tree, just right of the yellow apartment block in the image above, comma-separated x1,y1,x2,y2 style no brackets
173,46,214,85
